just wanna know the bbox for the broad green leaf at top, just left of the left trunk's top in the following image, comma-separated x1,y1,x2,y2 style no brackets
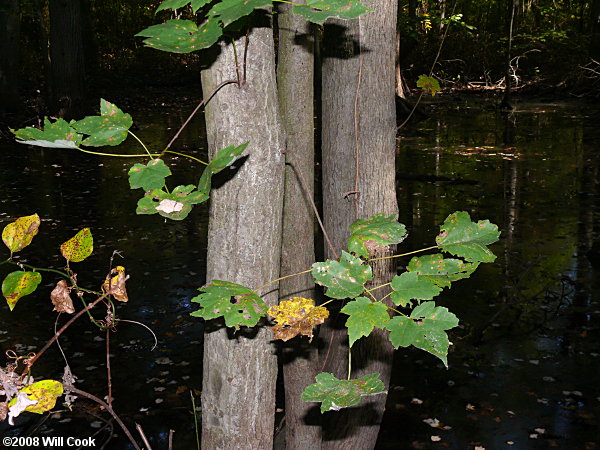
136,19,223,53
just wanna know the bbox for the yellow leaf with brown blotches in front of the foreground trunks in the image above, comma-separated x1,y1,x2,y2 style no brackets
268,297,329,341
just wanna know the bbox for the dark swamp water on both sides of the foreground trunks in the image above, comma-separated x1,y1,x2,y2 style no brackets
0,98,600,449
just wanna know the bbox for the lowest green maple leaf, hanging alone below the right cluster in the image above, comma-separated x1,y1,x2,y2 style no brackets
302,372,385,413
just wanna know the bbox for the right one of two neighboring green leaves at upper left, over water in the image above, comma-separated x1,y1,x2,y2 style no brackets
71,99,133,147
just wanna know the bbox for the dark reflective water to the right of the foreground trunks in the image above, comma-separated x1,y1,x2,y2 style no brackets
379,100,600,448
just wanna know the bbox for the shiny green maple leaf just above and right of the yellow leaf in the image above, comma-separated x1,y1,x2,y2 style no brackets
312,251,373,299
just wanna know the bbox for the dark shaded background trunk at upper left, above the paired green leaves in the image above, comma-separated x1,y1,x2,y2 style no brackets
49,0,86,119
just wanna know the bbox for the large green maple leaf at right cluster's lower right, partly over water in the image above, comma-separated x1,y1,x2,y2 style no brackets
386,302,458,367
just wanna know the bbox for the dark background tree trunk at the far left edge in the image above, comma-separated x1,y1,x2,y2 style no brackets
0,0,20,113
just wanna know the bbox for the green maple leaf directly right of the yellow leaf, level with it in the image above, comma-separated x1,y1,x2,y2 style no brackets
342,297,390,347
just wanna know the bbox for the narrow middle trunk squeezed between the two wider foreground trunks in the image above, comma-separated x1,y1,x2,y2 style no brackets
277,1,321,450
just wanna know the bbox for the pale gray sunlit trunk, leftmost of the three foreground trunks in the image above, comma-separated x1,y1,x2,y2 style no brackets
202,9,285,450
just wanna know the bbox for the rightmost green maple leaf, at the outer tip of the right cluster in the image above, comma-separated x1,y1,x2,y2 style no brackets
435,211,500,262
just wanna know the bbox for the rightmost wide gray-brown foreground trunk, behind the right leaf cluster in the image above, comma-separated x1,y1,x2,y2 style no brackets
320,0,398,450
